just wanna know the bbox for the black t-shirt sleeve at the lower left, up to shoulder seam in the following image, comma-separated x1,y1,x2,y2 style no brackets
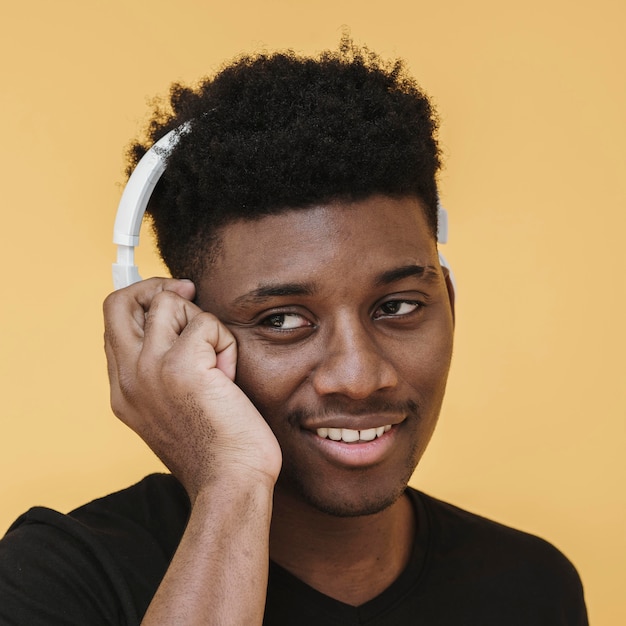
0,507,139,626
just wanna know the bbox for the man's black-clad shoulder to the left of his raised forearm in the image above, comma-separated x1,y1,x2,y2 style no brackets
0,475,188,624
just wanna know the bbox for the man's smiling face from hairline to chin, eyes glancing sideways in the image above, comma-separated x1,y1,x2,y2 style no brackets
197,196,453,516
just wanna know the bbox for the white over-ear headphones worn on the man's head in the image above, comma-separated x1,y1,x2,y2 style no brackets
113,122,454,289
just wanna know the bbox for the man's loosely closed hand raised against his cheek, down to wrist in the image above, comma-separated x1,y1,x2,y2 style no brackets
104,279,281,502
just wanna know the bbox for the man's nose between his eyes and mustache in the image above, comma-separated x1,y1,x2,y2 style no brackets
312,319,398,400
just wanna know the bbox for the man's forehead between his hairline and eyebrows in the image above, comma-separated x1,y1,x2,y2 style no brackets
199,196,438,296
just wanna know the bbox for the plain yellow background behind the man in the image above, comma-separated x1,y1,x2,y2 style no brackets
0,0,626,626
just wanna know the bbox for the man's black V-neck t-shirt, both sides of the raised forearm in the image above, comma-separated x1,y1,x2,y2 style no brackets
0,475,588,626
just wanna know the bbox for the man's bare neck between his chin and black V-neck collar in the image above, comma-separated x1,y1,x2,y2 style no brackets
270,490,416,606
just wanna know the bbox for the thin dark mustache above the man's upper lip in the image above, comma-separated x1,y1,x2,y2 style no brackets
287,399,420,426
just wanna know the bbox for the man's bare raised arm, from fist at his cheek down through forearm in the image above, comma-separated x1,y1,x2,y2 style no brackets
104,279,281,626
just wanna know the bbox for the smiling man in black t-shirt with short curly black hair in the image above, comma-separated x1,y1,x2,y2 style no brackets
0,39,587,626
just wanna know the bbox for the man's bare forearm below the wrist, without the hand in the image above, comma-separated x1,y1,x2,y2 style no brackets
142,482,273,626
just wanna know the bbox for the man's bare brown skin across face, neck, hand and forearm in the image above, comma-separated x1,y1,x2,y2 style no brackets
103,196,453,623
